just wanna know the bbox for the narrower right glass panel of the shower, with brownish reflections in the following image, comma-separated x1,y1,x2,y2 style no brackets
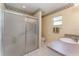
26,18,39,53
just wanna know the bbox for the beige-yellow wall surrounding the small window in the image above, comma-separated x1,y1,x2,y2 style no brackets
42,6,79,41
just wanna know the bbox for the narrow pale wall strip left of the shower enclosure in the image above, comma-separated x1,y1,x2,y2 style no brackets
0,3,5,55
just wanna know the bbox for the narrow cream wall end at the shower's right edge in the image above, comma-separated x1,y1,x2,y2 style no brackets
33,11,42,47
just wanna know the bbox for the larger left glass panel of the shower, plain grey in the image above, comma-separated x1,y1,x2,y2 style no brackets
4,12,25,56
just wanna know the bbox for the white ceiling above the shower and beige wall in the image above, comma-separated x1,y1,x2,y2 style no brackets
6,3,71,16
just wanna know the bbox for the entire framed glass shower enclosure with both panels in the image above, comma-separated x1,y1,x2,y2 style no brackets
3,12,39,56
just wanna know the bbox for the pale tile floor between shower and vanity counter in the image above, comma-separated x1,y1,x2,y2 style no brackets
25,42,62,56
